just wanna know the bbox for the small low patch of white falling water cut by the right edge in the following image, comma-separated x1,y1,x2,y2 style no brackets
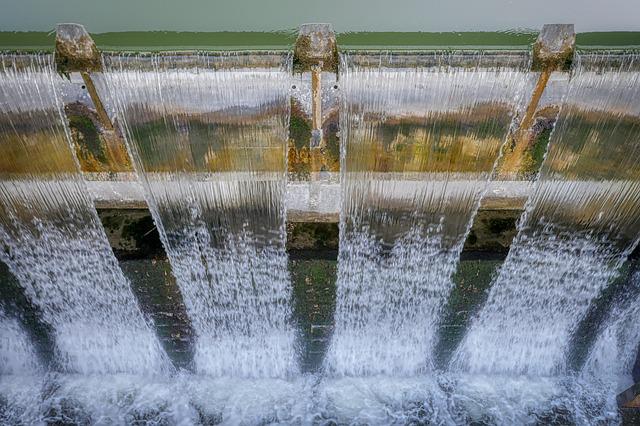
583,272,640,391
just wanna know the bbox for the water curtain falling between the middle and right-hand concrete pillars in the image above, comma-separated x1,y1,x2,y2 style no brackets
326,54,531,376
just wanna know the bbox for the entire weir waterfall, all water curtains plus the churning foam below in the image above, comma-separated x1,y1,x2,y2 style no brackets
0,45,640,424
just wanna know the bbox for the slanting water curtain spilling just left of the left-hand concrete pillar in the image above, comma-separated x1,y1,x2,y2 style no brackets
0,55,168,374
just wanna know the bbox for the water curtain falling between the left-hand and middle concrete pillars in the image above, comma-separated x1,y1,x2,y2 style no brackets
99,55,297,377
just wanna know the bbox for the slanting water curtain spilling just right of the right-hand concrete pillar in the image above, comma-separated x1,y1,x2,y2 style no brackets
453,54,640,375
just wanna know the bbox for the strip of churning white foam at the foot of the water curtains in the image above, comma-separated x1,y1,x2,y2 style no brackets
0,373,617,425
